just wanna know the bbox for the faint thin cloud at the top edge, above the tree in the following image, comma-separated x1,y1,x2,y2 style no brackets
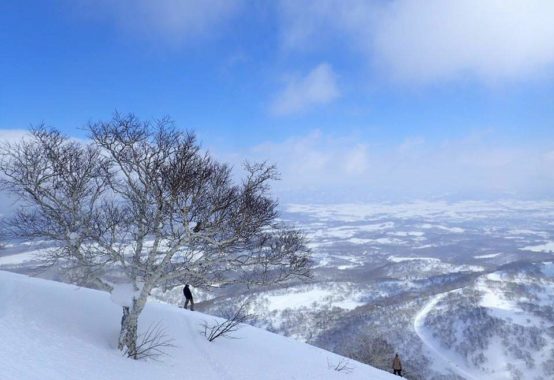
81,0,242,46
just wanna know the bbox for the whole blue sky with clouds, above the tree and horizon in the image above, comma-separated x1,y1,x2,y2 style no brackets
0,0,554,200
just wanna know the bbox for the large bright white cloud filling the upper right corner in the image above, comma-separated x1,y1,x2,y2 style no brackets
375,0,554,82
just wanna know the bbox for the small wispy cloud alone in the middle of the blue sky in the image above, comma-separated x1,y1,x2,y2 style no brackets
271,63,340,115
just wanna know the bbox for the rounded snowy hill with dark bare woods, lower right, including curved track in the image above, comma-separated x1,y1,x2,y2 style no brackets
413,268,554,380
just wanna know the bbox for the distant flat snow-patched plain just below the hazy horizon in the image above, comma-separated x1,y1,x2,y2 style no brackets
284,200,554,270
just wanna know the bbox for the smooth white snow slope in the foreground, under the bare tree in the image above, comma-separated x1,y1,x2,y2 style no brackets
0,271,397,380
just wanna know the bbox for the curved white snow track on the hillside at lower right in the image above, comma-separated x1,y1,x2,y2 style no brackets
414,293,478,380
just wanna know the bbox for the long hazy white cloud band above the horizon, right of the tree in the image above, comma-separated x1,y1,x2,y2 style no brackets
241,132,554,200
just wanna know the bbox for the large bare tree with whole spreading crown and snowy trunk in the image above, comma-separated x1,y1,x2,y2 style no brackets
0,115,309,358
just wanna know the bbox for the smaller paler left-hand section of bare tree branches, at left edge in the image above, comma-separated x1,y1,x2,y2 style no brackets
0,125,111,290
